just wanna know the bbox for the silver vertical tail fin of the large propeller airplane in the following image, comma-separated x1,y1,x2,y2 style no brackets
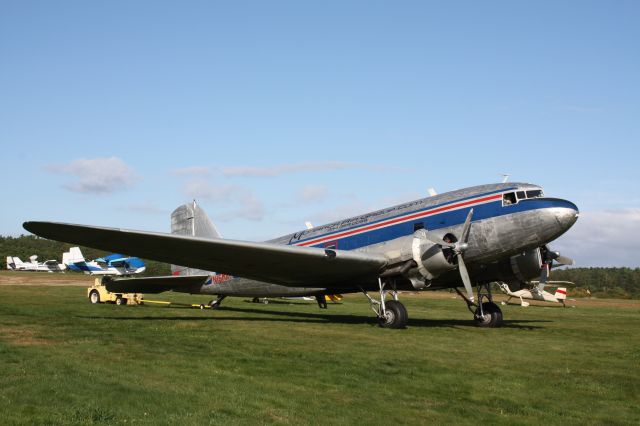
171,200,222,276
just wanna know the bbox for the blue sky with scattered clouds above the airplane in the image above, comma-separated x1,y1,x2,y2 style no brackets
0,0,640,267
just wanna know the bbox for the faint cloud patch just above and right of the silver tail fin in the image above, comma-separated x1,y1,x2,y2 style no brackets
184,179,265,221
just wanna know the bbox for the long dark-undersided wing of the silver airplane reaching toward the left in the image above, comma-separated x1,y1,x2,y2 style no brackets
23,222,388,288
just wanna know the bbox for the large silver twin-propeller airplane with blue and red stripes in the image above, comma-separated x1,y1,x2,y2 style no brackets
23,183,579,328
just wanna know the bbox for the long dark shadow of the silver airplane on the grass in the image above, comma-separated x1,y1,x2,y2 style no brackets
81,307,551,330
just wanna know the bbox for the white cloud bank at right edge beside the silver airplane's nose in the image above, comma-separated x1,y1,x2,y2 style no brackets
551,208,640,267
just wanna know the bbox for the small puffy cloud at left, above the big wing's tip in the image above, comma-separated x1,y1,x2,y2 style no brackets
46,157,138,194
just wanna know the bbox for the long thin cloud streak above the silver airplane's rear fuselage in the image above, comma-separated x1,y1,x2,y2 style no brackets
221,161,390,177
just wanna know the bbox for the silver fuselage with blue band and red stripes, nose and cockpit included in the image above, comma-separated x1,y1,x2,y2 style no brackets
196,183,578,297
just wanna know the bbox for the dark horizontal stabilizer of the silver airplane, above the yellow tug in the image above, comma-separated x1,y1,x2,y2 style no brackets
104,275,209,294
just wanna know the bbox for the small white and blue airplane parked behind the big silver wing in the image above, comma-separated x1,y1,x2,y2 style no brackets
62,247,146,275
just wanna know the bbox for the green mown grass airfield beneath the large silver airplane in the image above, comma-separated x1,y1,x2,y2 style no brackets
0,273,640,424
